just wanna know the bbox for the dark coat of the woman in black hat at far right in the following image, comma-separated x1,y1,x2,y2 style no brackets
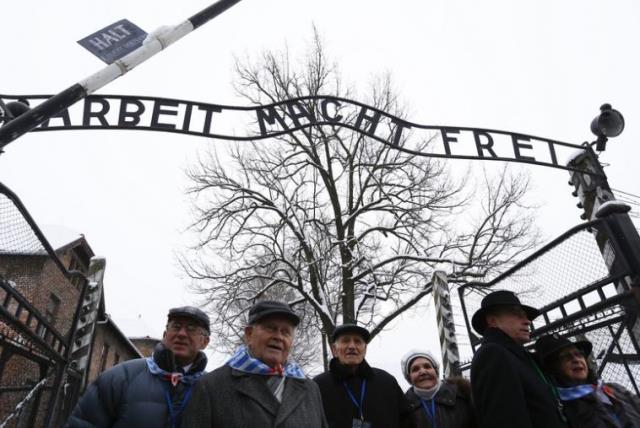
563,384,640,428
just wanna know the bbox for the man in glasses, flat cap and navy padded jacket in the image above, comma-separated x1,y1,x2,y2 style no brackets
66,306,210,428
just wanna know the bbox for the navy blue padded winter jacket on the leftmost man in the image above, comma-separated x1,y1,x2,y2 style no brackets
65,346,207,428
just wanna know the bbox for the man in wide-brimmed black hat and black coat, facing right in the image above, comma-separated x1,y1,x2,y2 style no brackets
471,290,567,428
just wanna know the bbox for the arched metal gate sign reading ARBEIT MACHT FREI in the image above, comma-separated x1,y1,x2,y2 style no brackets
0,95,597,175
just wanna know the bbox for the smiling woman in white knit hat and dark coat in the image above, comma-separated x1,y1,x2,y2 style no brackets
400,349,475,428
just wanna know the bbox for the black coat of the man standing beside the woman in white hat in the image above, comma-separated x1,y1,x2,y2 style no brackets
313,358,415,428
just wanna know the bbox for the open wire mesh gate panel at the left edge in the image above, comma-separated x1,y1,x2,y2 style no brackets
0,183,80,428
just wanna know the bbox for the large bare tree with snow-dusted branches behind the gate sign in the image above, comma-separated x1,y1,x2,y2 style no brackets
183,31,536,370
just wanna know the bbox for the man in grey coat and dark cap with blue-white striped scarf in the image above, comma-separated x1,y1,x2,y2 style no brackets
184,301,327,428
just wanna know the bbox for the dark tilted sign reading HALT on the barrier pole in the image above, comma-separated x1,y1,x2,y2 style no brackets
78,19,147,64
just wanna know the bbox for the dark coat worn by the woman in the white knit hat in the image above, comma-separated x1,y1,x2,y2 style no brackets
406,382,475,428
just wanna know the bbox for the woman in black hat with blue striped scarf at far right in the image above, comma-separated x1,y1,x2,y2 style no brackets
535,335,640,428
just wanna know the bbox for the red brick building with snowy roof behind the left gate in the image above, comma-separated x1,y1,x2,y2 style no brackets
0,227,142,428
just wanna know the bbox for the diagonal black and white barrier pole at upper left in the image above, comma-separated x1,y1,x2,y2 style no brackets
0,0,241,153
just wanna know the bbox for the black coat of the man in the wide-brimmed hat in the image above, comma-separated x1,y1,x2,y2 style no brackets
471,328,567,428
